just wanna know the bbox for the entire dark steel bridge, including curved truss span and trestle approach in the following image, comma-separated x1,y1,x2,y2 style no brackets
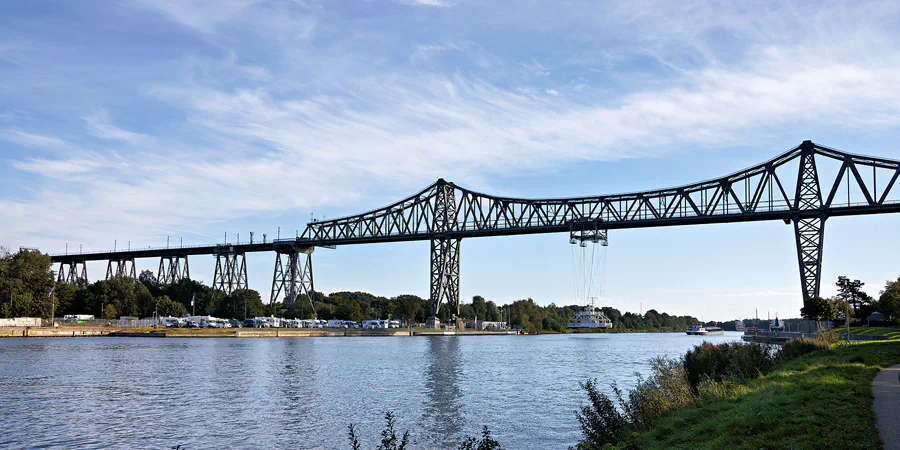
51,141,900,326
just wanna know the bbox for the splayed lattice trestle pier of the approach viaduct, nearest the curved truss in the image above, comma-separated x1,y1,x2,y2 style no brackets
269,245,316,312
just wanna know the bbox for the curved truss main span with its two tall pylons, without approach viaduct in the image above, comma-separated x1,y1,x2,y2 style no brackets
300,141,900,313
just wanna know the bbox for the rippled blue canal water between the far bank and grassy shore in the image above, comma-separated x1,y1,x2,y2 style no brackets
0,333,739,450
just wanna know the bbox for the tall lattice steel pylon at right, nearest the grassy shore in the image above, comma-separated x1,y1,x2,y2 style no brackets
792,141,828,303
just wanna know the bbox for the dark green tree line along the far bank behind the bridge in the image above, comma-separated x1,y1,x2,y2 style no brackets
0,249,697,333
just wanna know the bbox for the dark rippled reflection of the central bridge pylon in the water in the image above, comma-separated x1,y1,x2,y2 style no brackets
422,336,464,448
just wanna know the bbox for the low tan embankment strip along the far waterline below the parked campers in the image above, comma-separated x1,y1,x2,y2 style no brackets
0,327,516,338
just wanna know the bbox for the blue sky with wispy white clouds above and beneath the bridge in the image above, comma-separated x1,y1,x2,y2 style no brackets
0,0,900,319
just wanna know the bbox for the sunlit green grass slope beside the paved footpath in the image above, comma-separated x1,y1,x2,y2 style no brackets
634,340,900,449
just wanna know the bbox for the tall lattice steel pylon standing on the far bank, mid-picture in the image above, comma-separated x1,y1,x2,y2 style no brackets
425,179,461,328
